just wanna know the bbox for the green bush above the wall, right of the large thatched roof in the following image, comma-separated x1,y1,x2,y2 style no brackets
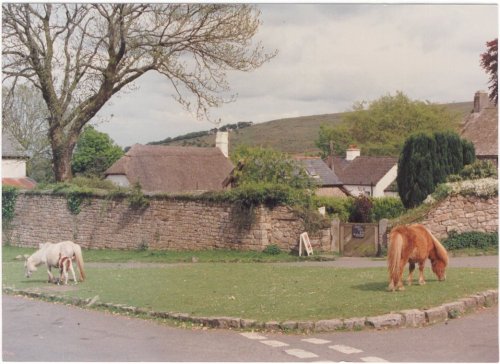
231,146,314,189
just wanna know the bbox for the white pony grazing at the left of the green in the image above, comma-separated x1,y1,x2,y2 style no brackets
24,241,85,283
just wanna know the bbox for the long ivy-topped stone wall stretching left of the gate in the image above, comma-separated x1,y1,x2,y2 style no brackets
3,193,332,252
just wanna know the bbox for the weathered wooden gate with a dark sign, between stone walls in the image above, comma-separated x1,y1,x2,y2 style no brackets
339,223,379,257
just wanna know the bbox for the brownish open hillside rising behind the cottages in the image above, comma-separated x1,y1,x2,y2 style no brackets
149,102,473,154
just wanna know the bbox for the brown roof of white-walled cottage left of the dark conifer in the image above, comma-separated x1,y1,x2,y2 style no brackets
327,156,398,186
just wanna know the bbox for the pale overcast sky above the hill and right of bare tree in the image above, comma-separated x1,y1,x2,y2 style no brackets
97,4,498,146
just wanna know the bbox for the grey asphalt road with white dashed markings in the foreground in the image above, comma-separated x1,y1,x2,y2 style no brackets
2,295,499,362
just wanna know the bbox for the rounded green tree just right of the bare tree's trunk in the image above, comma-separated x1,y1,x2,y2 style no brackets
71,125,123,176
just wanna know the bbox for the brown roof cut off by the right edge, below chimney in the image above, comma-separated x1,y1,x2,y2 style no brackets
461,105,498,158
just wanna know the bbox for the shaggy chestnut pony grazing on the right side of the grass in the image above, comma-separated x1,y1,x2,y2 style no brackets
387,224,448,291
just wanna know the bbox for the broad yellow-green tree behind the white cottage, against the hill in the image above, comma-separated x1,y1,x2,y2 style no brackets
316,91,460,156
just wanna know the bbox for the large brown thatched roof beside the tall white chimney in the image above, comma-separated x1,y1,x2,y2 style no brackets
105,144,234,194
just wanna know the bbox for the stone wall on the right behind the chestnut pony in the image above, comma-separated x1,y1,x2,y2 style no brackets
421,195,498,239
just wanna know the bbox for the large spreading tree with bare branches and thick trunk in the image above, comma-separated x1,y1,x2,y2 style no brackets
2,4,275,181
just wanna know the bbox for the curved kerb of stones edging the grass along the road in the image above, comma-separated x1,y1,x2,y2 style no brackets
3,287,498,333
